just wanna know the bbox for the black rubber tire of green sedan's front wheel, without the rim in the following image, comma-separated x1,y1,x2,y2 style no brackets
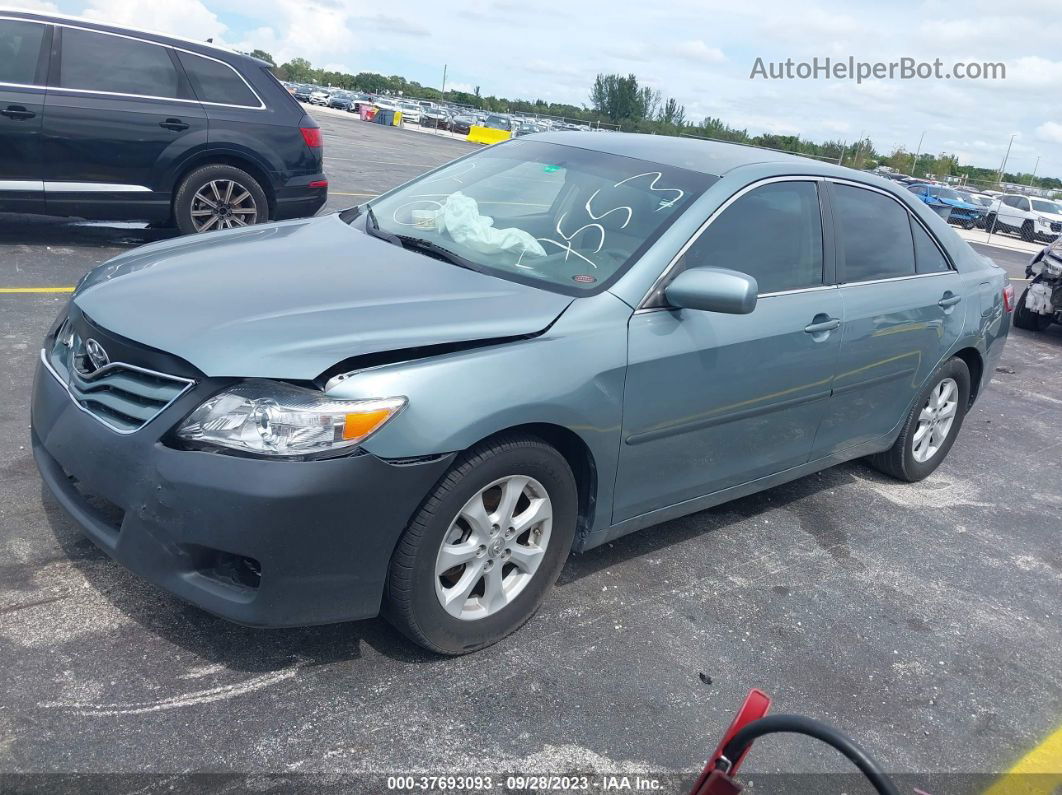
382,435,579,655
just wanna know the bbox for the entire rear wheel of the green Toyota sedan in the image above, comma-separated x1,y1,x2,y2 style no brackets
868,357,970,483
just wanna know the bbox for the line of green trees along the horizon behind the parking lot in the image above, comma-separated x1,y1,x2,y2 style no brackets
251,50,1062,189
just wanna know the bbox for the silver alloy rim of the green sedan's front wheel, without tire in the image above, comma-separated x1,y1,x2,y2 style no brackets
435,474,553,621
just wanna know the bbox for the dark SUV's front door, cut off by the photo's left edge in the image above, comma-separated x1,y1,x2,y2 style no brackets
0,19,51,212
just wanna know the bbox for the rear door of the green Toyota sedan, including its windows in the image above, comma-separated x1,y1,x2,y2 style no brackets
816,182,965,455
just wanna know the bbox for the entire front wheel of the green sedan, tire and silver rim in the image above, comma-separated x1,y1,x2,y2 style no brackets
383,435,579,654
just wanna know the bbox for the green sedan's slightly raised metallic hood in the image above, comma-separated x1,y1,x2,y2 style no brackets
73,215,572,380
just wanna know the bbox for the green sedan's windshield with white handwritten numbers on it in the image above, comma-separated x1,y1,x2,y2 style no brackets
371,140,717,295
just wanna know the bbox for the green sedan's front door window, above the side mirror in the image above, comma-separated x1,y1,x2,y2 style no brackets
682,182,823,294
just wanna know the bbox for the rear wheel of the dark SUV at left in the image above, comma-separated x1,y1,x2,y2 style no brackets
173,165,269,235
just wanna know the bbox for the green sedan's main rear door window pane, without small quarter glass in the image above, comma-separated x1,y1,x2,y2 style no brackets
830,184,914,282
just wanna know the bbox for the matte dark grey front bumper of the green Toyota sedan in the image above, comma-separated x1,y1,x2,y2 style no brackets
32,358,452,626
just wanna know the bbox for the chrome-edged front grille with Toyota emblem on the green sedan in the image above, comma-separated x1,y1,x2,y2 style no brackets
44,323,193,433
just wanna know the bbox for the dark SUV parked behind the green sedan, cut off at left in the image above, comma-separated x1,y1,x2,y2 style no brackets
0,11,328,234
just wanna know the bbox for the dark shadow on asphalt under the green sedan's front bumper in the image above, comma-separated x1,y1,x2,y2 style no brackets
40,487,435,673
